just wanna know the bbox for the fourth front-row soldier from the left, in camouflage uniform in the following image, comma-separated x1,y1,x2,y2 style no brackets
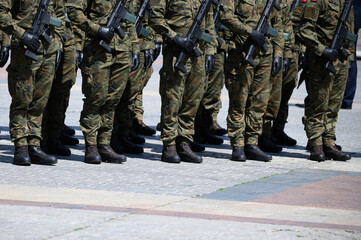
221,0,283,161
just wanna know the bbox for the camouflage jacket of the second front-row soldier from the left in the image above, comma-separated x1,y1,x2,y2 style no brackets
66,0,140,53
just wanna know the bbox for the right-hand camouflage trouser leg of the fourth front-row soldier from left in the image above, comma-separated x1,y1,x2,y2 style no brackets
245,54,272,145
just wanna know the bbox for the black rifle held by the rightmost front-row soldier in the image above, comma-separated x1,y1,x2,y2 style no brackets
325,0,357,74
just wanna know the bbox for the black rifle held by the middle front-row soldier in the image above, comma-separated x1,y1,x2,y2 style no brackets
174,0,216,73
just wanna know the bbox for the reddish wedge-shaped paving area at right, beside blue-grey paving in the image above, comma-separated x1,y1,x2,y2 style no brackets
252,175,361,211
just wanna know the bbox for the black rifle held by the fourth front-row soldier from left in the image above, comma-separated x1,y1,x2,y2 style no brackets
245,0,281,67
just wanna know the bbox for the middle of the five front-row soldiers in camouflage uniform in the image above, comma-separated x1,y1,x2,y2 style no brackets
150,0,217,163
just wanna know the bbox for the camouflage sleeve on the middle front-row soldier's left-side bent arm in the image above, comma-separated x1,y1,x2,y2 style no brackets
149,0,177,39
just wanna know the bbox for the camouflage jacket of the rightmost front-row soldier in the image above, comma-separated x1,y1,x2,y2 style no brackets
299,0,354,56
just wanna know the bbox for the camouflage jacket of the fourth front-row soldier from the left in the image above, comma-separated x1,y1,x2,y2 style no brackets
221,0,284,57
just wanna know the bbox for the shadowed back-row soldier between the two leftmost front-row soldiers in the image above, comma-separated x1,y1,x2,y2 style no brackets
43,0,81,156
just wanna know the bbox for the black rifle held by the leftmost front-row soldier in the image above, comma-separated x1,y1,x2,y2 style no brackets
24,0,62,62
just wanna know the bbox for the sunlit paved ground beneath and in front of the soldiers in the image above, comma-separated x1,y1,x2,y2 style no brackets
0,54,361,240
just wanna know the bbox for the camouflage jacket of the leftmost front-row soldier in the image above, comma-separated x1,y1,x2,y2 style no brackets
0,0,63,53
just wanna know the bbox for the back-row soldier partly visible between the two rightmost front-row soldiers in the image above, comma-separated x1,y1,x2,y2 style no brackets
272,0,301,146
